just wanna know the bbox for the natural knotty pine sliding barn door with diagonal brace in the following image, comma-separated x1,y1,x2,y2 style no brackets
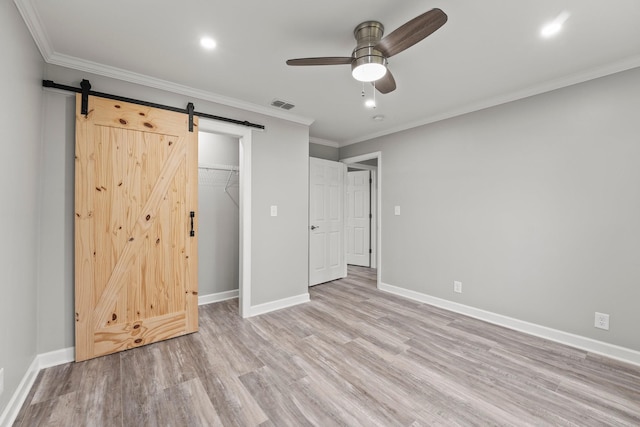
75,95,198,361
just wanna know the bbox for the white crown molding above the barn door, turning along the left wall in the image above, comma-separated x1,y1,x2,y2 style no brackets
14,0,315,126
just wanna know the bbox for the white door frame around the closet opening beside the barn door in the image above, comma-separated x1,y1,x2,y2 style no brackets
198,117,256,318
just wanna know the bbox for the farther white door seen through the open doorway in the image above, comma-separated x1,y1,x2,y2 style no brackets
346,171,371,267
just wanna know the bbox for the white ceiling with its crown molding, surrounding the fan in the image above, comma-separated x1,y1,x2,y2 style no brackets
15,0,640,146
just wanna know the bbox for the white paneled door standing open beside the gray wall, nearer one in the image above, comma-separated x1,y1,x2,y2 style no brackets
309,157,347,286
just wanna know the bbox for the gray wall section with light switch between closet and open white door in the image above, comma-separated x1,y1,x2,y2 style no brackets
251,120,309,305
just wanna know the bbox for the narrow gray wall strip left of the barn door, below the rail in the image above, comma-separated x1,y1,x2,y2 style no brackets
38,90,76,353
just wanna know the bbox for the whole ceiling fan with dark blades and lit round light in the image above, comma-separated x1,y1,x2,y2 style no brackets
287,8,447,93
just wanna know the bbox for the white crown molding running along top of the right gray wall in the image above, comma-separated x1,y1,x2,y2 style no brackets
340,55,640,147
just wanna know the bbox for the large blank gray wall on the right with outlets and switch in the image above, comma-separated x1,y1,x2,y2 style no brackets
340,69,640,350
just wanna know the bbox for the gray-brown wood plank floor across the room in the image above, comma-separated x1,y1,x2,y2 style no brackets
14,267,640,426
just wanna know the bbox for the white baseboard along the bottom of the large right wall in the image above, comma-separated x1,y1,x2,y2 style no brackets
378,283,640,366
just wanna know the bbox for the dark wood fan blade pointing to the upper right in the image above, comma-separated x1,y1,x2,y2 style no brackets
376,8,447,58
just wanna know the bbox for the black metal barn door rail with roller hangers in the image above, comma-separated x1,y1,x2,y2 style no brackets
42,79,264,132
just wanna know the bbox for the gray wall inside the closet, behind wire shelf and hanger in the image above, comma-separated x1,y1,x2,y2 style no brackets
197,132,240,296
